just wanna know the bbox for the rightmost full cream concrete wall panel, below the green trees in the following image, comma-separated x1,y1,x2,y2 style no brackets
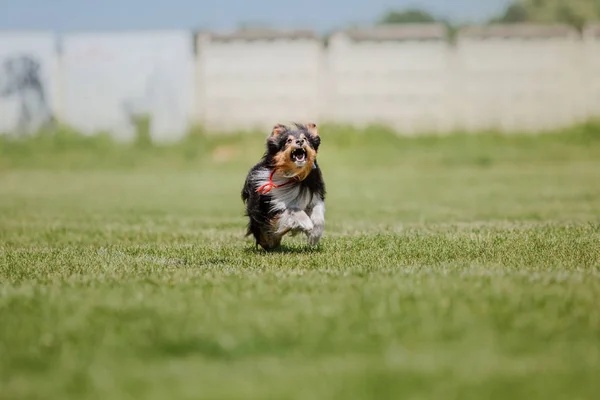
454,25,584,131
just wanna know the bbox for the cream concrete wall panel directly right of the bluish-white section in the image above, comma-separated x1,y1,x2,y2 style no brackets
197,30,327,130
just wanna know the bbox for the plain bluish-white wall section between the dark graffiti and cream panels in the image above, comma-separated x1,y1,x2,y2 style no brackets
61,31,194,140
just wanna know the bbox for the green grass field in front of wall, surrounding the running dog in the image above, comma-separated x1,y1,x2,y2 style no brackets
0,125,600,400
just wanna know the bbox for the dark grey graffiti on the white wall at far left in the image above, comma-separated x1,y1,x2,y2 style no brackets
0,55,52,132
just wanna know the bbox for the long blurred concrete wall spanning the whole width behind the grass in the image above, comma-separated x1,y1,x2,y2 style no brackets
0,25,600,140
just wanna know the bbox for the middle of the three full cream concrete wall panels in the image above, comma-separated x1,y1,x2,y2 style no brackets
326,25,453,133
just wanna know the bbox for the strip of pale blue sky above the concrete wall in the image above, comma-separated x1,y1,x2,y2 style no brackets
0,0,510,31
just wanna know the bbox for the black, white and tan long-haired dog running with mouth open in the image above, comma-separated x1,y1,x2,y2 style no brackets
242,124,325,251
